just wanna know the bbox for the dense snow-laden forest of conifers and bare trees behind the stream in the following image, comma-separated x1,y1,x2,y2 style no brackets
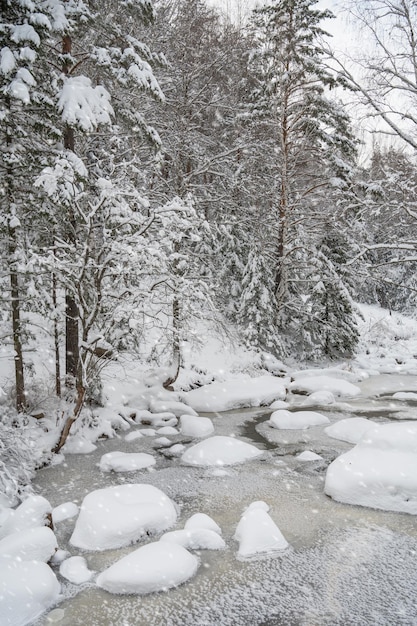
0,0,417,502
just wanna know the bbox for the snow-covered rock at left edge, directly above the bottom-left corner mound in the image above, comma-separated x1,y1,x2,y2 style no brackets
0,526,58,563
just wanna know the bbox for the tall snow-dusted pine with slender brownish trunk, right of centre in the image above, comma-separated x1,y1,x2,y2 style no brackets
244,0,356,354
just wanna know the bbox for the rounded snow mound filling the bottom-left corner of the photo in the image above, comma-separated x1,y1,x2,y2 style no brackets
0,559,61,626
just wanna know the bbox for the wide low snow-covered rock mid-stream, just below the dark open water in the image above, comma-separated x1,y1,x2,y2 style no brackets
181,436,263,466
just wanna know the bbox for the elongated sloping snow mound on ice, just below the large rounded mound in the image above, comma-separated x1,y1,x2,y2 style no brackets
97,541,198,594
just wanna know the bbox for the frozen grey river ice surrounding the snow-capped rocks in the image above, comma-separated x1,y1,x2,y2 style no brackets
35,376,417,626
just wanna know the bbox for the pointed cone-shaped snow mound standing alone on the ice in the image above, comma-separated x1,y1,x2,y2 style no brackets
234,501,288,559
